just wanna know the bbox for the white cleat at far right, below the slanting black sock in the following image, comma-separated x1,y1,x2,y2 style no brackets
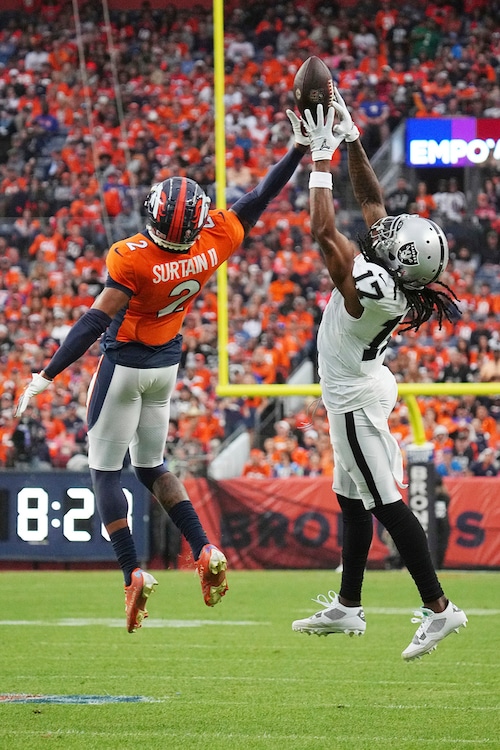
401,602,467,661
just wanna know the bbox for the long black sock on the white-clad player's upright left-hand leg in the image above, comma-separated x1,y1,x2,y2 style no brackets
337,495,373,602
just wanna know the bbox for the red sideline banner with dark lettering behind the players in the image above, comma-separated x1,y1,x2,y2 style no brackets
182,477,500,570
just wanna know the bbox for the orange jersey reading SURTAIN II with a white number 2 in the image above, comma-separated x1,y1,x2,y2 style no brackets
106,210,244,347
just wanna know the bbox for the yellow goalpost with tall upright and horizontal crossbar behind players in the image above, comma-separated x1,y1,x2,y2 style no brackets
213,0,500,445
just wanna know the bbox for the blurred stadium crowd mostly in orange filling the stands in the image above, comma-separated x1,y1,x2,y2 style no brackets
0,0,500,477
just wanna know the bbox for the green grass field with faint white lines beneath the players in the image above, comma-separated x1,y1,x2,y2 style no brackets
0,571,500,750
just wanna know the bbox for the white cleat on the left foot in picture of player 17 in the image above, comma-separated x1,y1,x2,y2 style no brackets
292,591,366,636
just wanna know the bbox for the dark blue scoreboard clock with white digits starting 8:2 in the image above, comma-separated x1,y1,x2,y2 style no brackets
0,471,151,562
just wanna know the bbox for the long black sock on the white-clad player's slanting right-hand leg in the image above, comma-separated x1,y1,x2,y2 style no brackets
372,500,443,602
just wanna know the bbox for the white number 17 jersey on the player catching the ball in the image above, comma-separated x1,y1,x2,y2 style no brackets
318,254,408,414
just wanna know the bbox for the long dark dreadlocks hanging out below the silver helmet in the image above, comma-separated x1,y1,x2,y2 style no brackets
358,233,461,333
